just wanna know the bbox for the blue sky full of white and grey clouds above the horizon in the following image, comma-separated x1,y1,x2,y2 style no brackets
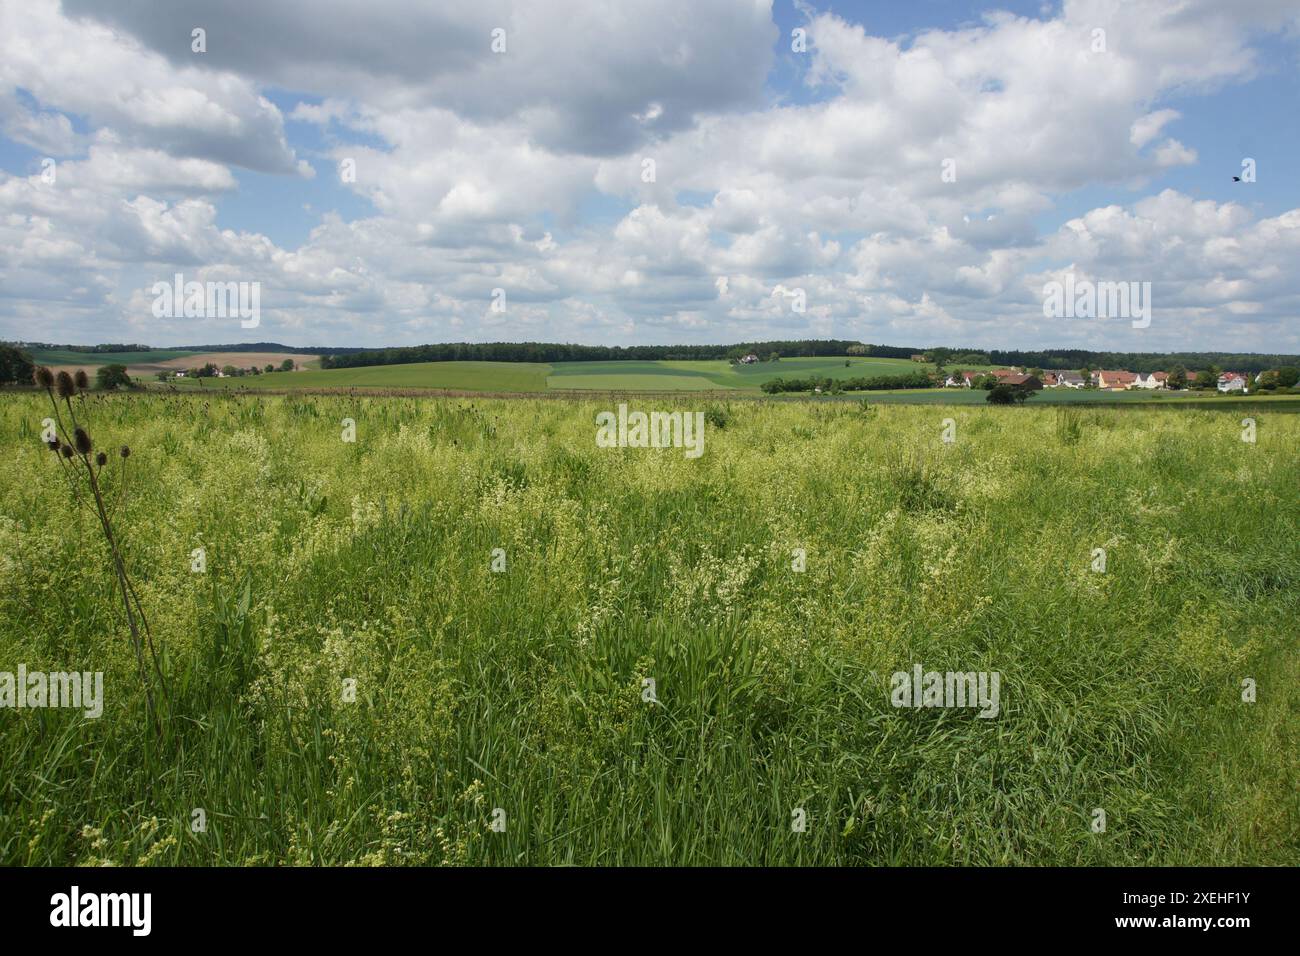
0,0,1300,352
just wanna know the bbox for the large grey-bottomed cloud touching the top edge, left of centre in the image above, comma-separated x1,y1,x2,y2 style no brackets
65,0,776,153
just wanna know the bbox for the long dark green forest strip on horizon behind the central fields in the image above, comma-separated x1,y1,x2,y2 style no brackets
321,339,861,368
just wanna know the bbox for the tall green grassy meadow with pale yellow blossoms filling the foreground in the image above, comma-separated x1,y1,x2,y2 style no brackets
0,390,1300,865
